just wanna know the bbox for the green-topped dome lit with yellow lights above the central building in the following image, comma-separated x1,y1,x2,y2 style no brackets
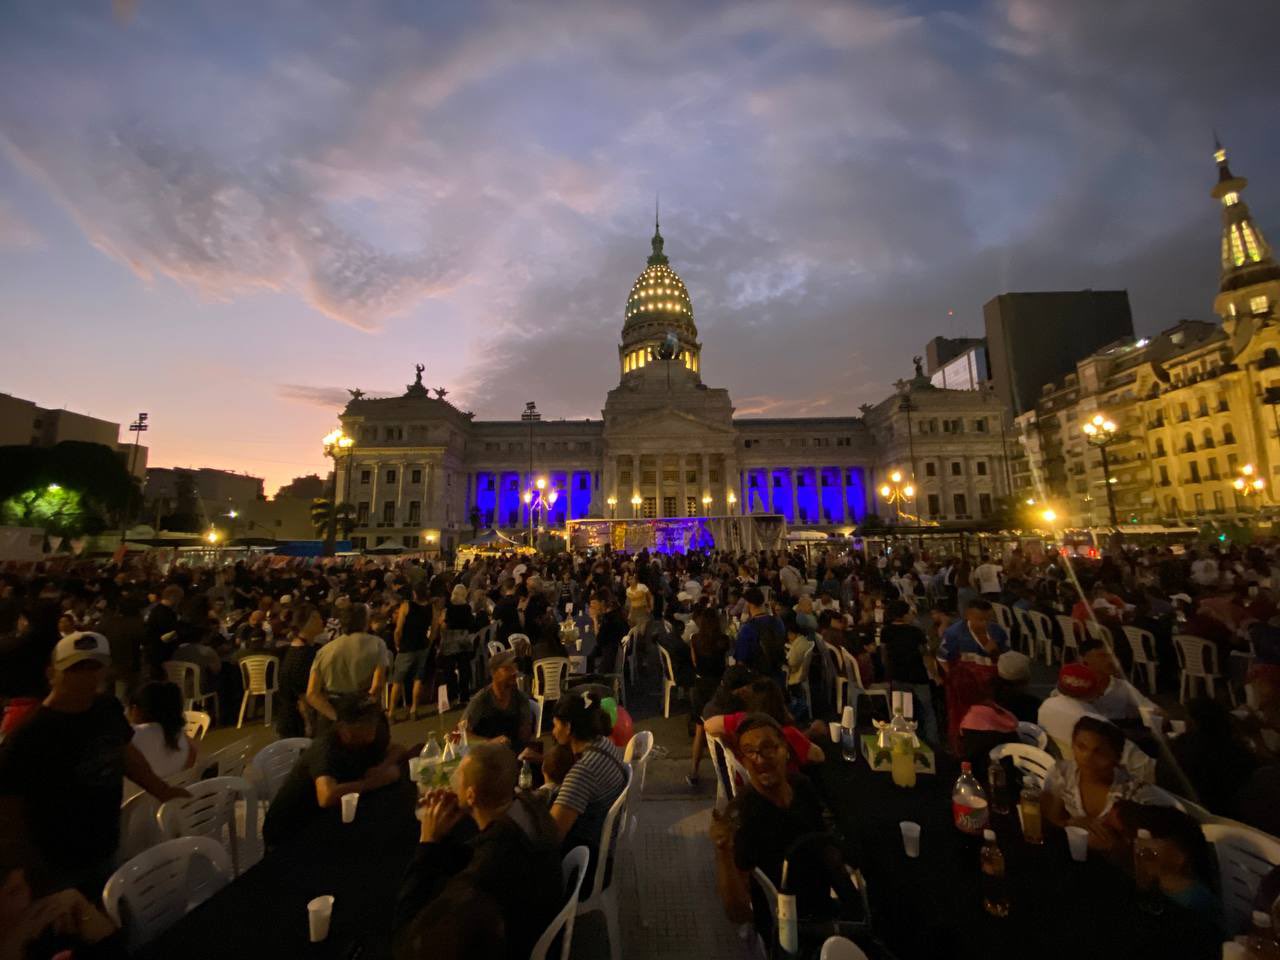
618,221,701,375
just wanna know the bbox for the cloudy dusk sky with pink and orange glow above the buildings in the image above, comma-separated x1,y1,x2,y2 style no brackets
0,0,1280,493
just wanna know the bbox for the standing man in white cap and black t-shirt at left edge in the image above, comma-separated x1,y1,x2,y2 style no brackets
0,632,188,900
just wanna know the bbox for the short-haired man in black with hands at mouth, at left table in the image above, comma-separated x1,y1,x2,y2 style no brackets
394,744,564,960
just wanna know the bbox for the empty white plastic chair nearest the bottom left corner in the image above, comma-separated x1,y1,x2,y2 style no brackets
102,837,232,950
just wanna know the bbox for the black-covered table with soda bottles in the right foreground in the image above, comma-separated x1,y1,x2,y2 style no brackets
813,751,1221,960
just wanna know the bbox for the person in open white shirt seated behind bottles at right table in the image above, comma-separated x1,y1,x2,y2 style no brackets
1041,717,1143,851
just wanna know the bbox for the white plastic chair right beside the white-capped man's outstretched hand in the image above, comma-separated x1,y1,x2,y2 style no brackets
156,777,262,877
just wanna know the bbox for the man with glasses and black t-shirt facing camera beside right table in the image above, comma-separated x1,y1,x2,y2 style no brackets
710,713,859,924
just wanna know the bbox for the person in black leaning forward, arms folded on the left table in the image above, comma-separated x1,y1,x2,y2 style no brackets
262,698,407,847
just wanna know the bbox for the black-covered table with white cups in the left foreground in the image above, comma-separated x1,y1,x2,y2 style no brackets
138,778,419,960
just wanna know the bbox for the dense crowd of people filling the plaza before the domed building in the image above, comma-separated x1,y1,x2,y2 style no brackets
0,541,1280,957
